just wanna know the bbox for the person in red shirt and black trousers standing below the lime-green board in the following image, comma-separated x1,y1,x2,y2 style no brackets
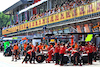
86,44,93,64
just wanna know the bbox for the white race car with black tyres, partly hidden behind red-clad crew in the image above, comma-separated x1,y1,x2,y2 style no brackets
36,50,88,64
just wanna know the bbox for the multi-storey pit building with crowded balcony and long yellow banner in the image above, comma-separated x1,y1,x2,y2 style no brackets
2,0,100,39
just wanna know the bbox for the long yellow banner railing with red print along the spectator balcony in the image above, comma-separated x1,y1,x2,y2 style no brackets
2,1,100,35
